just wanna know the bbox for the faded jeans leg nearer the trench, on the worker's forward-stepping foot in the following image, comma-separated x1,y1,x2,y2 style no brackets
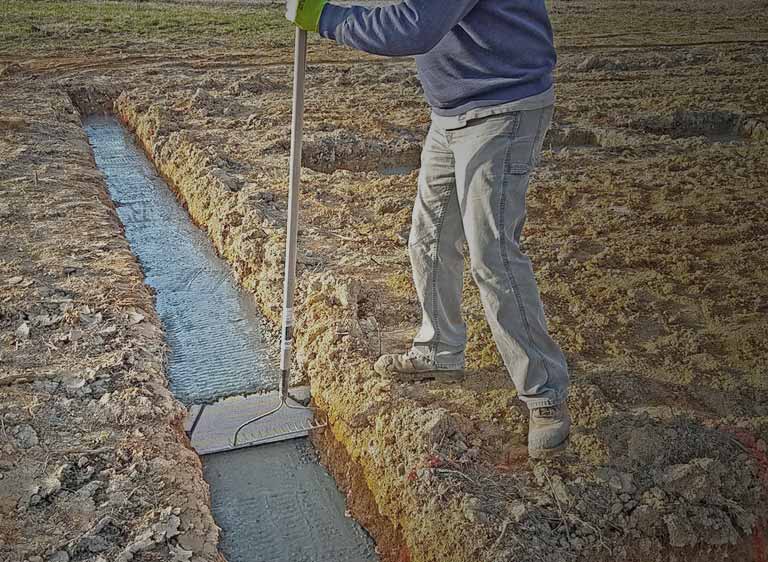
408,126,467,368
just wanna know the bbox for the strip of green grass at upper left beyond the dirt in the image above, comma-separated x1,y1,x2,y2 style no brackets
0,0,293,54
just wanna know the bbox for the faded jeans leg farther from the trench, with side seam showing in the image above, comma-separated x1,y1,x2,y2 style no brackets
448,107,568,407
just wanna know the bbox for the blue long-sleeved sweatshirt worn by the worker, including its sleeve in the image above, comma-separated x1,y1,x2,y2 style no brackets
319,0,556,116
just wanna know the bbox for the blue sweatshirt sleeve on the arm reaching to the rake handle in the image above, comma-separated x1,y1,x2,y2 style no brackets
319,0,479,57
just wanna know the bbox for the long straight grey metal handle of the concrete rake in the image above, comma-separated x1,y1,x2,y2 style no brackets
280,28,307,398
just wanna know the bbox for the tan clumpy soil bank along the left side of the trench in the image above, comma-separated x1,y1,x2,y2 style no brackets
0,84,221,562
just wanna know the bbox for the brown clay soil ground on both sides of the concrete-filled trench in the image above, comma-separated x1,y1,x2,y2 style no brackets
0,0,768,562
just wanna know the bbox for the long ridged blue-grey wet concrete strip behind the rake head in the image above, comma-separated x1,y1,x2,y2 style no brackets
84,116,278,405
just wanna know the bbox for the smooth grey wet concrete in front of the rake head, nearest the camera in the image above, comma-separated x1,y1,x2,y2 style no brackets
203,439,377,562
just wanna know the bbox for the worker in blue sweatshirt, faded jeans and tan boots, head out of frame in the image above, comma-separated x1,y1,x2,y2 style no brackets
286,0,571,458
